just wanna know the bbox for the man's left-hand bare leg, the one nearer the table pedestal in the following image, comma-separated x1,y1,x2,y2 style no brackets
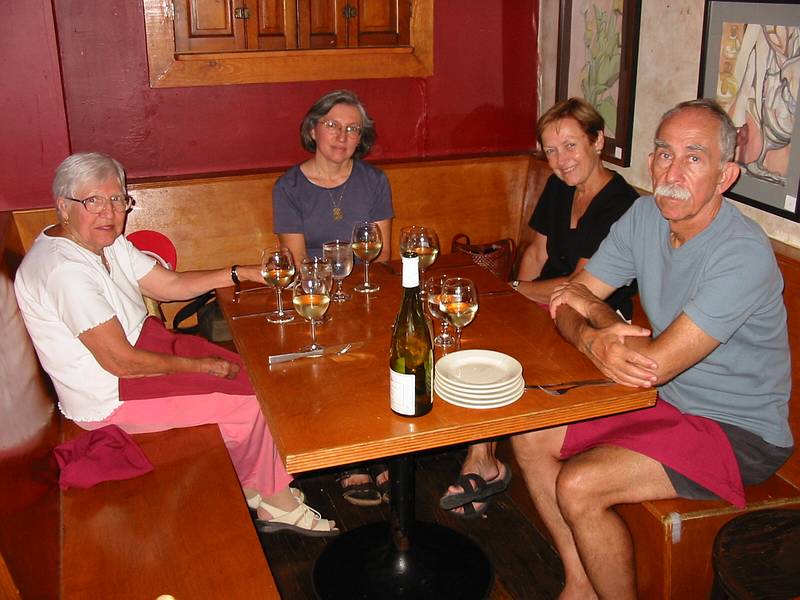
511,427,597,600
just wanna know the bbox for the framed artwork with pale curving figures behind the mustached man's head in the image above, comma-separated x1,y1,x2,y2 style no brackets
698,0,800,221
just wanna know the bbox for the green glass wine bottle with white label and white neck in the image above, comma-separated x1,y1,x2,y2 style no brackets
389,252,434,417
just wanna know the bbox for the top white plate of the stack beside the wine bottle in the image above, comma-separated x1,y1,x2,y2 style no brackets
436,350,522,390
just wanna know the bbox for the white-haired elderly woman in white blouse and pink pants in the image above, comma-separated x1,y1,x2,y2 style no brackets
15,153,338,536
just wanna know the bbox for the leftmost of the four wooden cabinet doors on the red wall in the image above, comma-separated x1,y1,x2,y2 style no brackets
173,0,247,52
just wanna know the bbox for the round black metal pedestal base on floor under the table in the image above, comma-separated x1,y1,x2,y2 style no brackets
314,522,493,600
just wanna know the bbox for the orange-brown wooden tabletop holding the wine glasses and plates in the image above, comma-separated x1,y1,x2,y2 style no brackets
217,255,656,473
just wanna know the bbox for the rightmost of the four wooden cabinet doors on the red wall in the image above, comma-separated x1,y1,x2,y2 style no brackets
348,0,411,46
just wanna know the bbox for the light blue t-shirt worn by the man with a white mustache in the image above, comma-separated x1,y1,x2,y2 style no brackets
586,196,792,447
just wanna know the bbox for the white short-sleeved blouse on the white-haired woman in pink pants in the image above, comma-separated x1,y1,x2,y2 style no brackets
14,228,155,421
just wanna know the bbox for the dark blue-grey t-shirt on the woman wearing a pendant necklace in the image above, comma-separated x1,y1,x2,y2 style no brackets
272,160,394,256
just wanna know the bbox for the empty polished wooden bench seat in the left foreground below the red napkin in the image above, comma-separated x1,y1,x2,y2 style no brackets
61,422,280,600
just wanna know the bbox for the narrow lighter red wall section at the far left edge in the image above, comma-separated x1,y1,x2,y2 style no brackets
0,0,69,210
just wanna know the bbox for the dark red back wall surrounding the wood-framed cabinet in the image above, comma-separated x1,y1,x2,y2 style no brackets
0,0,538,208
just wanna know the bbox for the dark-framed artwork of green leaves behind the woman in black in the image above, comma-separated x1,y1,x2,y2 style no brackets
556,0,641,167
